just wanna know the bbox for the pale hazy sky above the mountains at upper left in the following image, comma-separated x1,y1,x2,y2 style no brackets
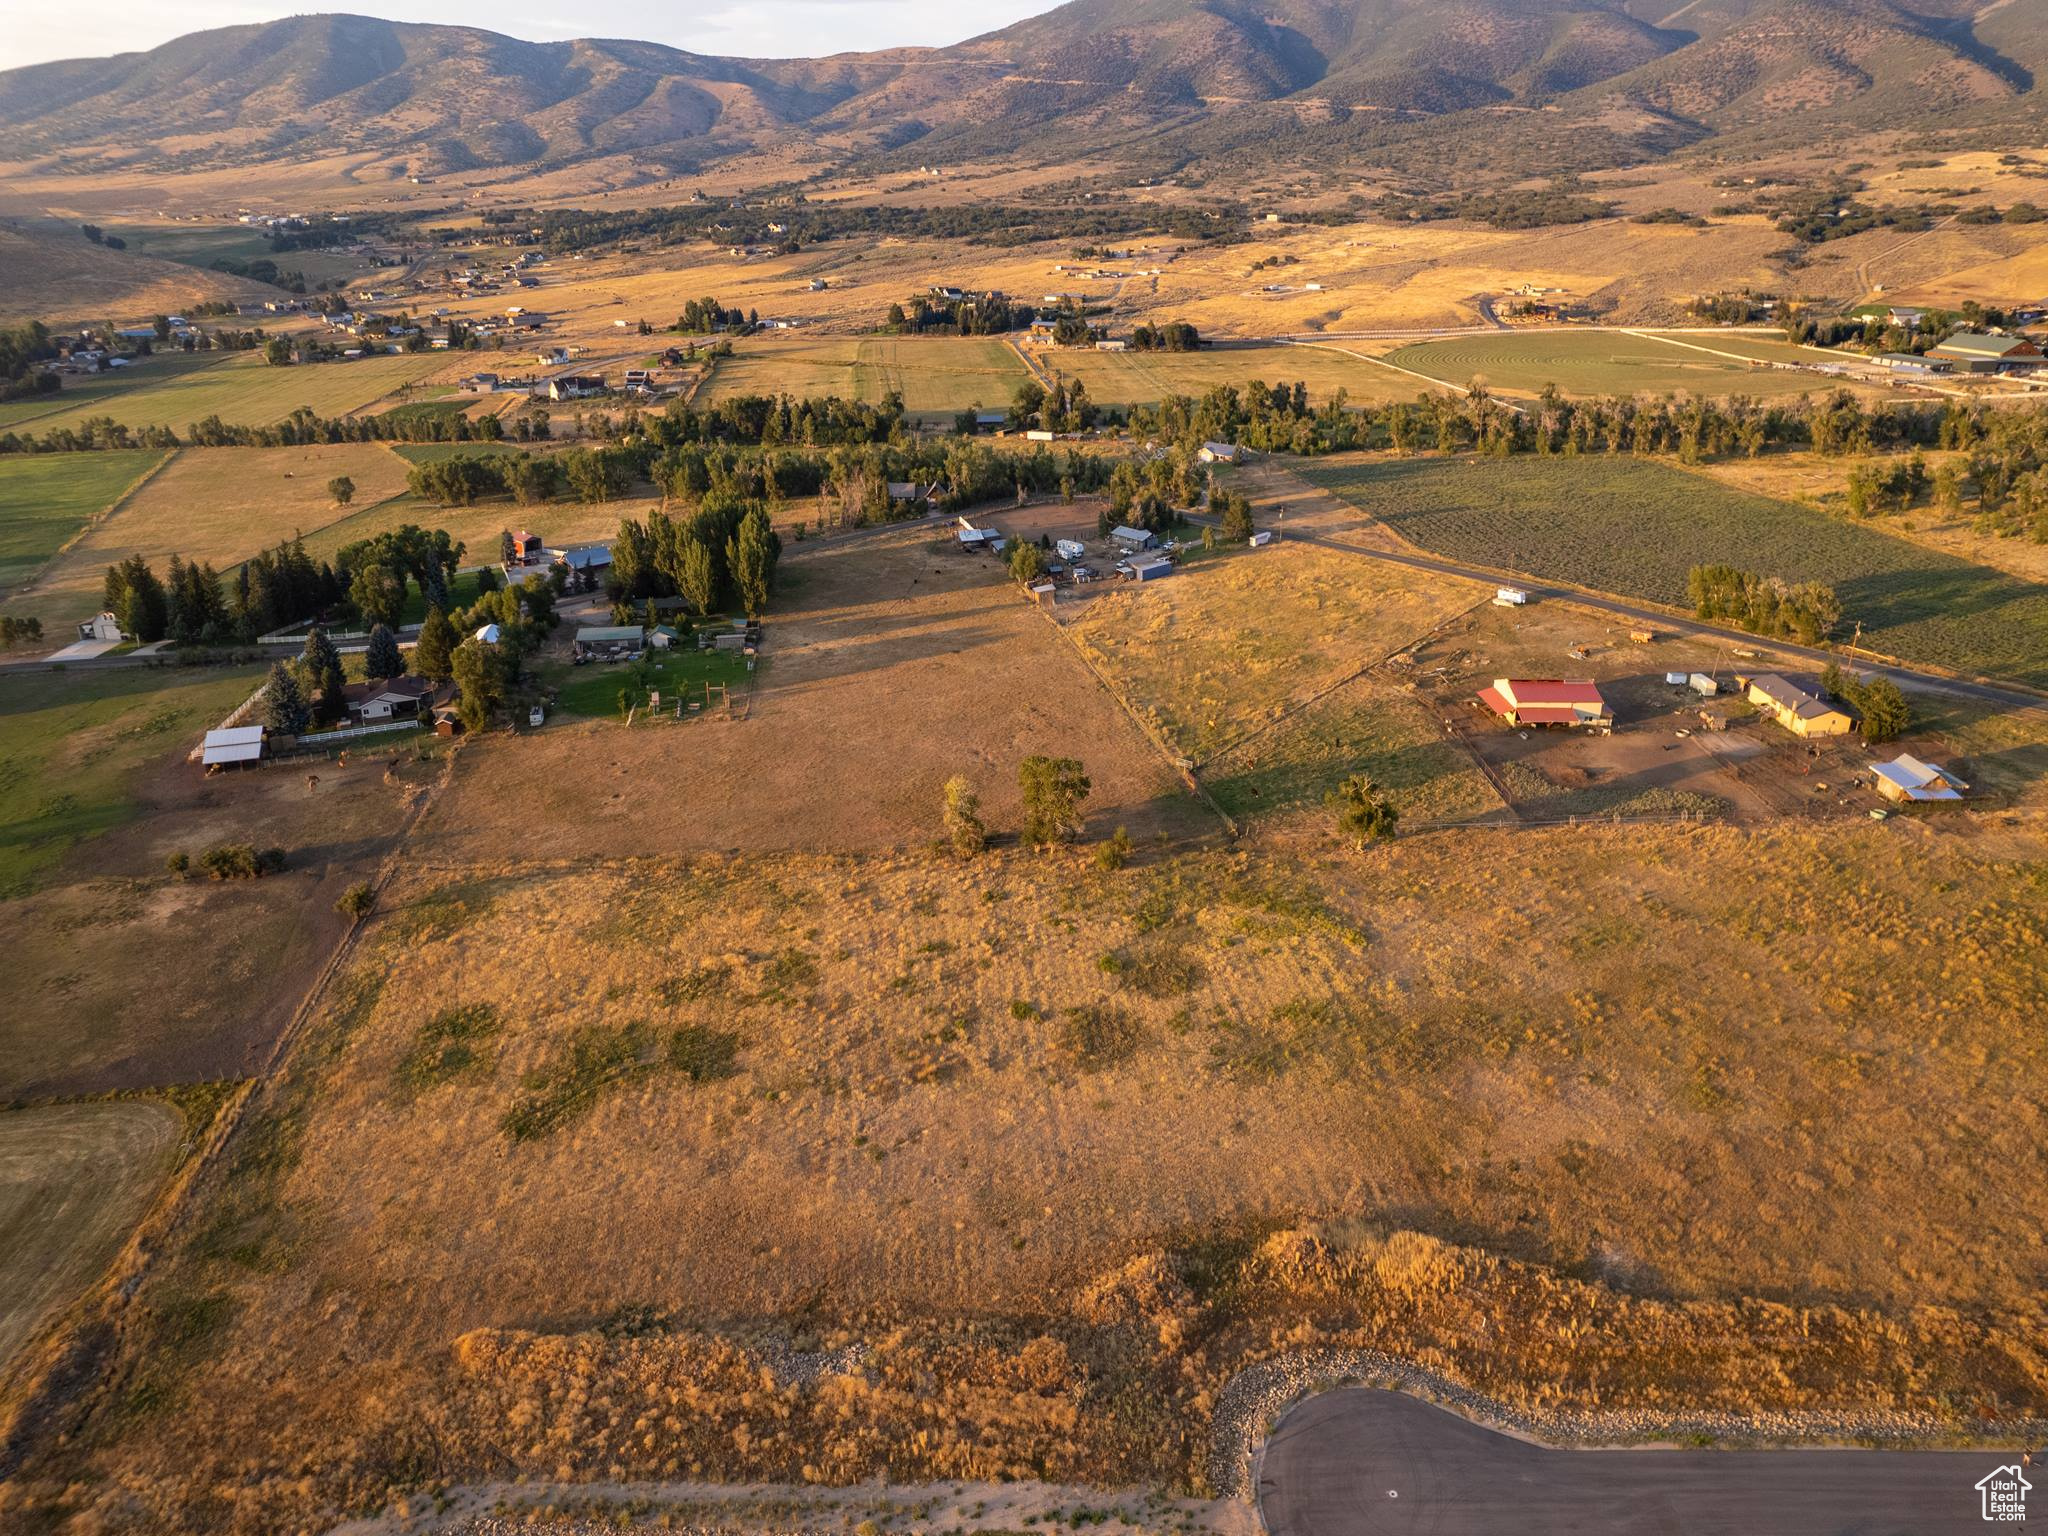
0,0,1057,70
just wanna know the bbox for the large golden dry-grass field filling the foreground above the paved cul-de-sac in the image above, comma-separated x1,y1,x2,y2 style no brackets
20,811,2048,1532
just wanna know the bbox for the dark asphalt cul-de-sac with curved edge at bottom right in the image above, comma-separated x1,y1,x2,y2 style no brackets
1260,1386,2048,1536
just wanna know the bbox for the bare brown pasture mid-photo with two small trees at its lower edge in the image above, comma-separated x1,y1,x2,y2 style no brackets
414,526,1219,862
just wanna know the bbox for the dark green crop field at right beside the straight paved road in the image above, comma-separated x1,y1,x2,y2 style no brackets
1298,457,2048,684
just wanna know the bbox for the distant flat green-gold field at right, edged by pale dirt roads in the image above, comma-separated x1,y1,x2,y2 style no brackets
1386,330,1875,397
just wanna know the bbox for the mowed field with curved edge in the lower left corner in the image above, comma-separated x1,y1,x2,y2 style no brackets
0,1100,182,1372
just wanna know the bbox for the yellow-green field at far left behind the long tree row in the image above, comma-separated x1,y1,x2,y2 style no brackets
10,352,465,436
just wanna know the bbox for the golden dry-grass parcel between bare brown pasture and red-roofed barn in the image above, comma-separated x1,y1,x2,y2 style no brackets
1057,541,1493,764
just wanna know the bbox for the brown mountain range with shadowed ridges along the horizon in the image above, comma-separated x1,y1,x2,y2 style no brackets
0,0,2048,185
